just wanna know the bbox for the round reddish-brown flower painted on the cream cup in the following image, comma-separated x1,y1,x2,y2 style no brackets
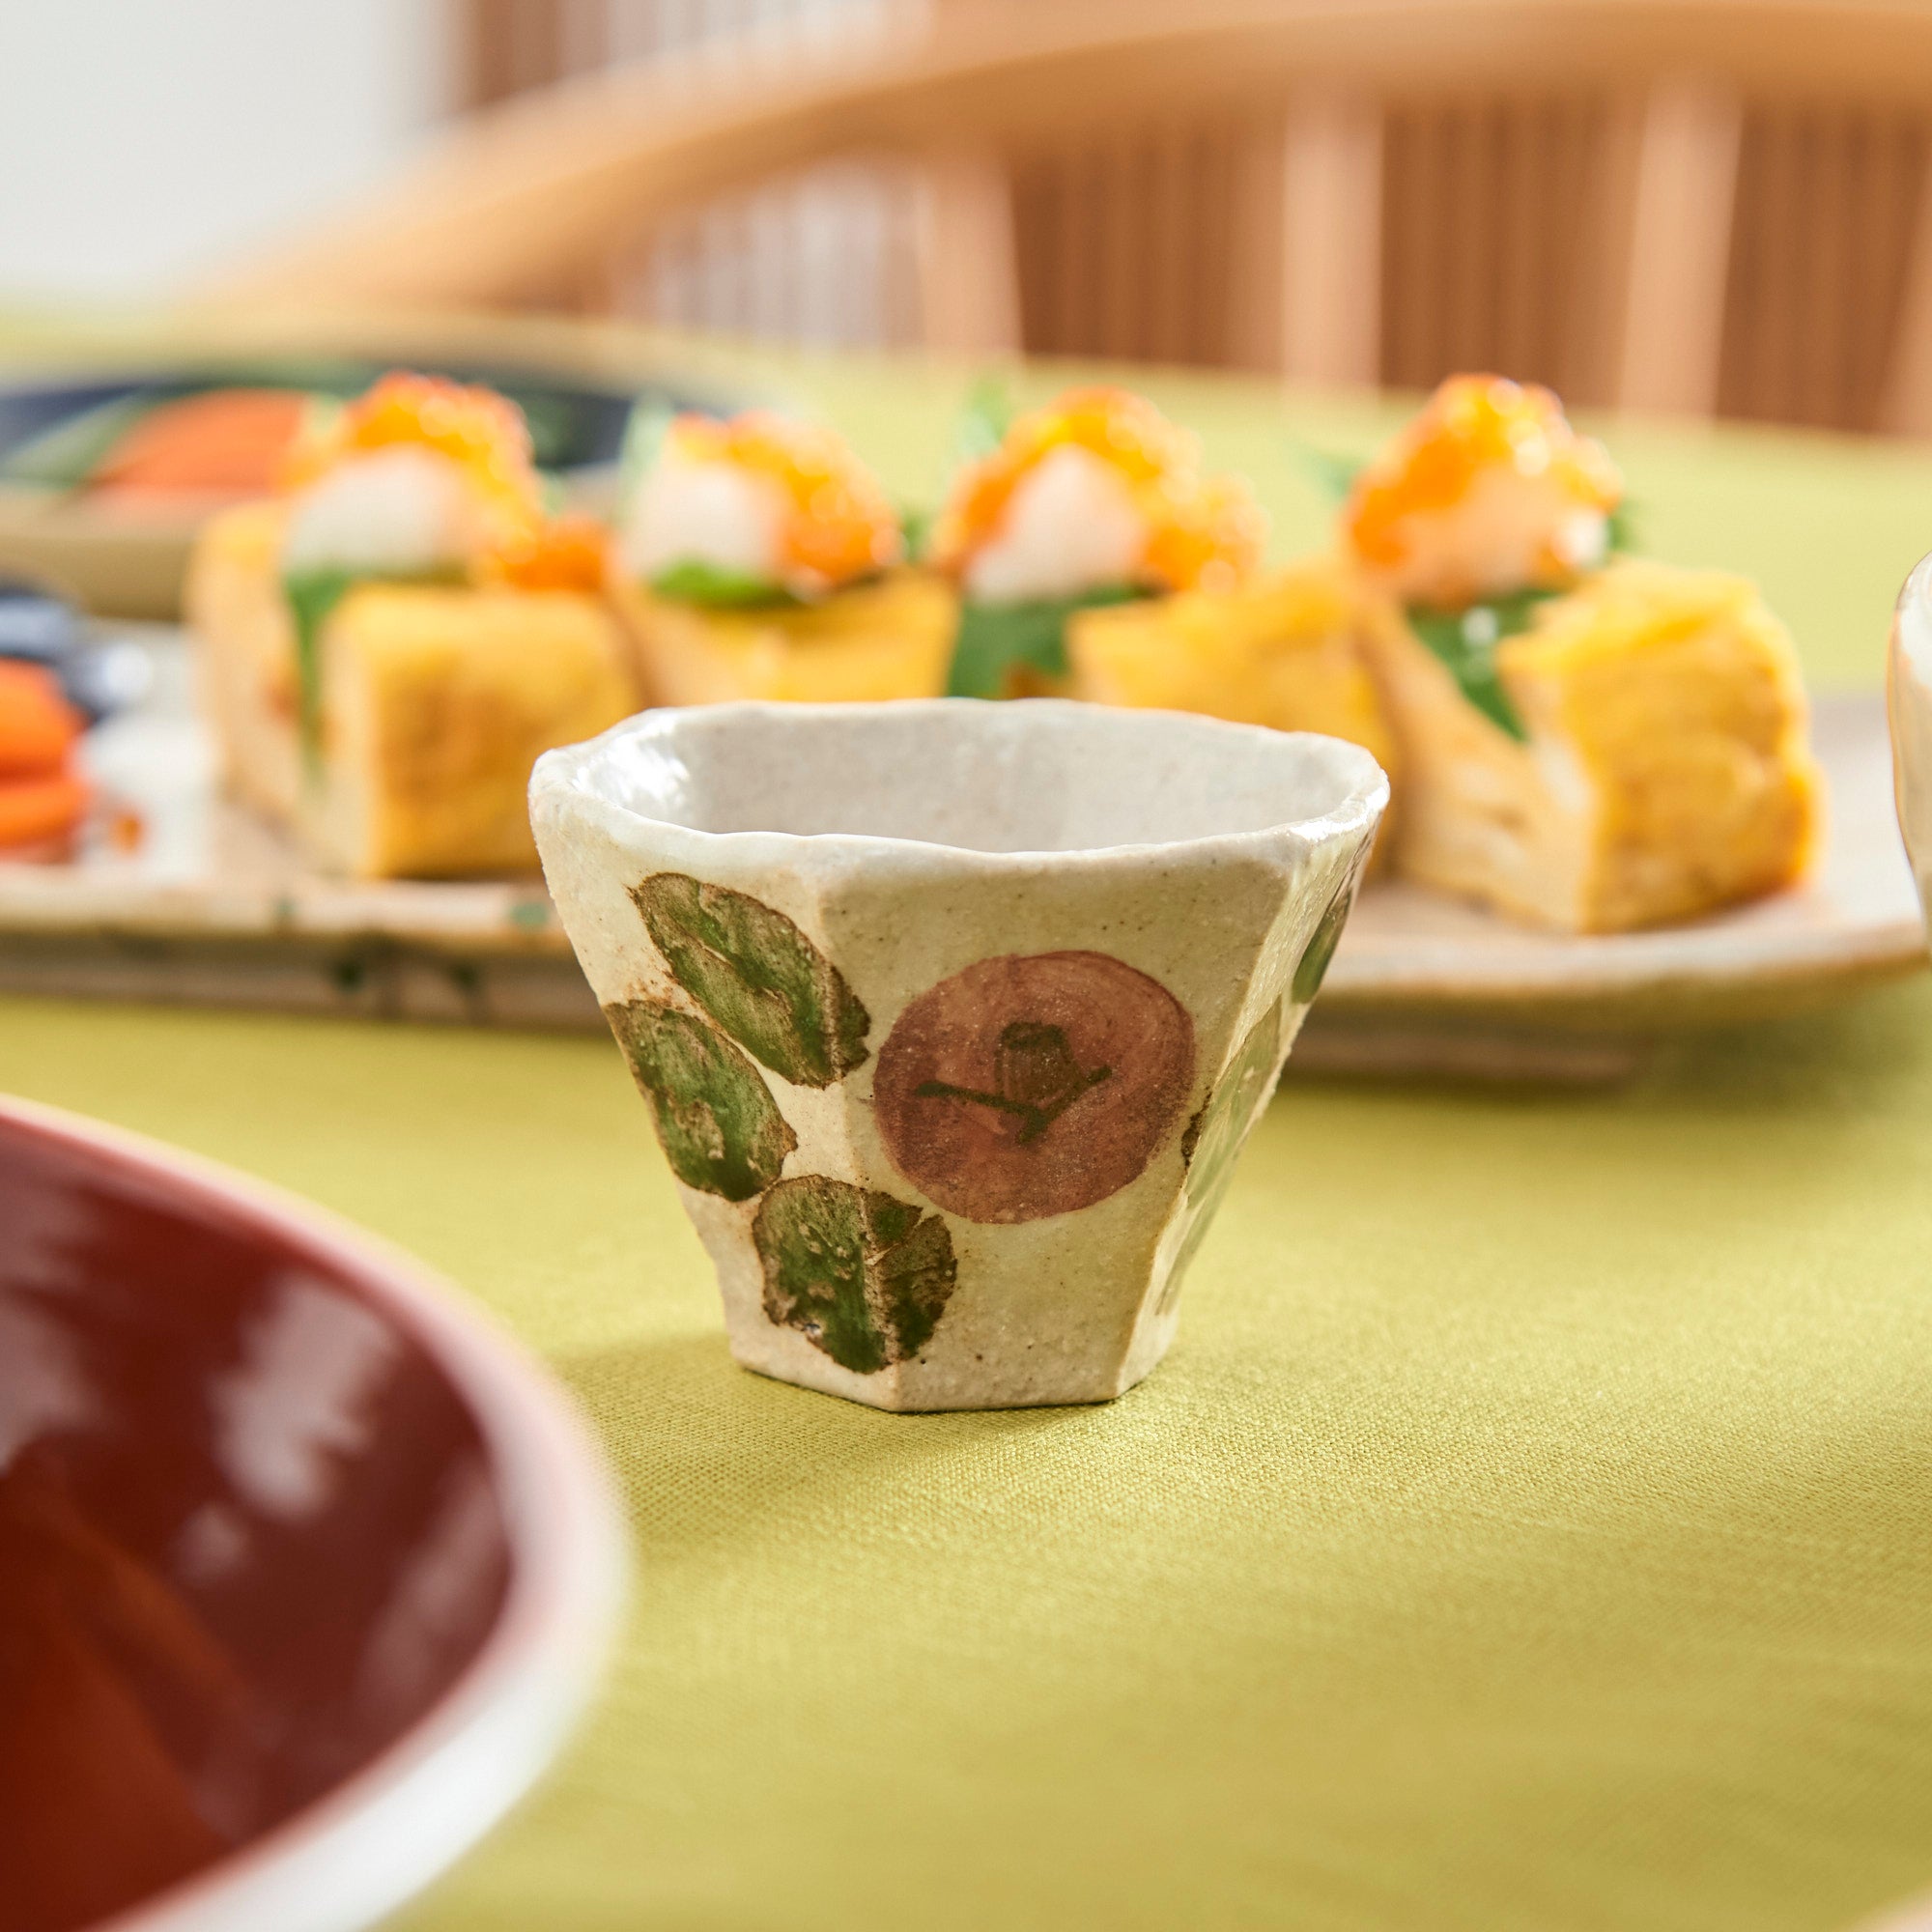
871,952,1194,1221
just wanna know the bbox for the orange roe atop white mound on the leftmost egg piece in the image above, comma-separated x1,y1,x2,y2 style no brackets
284,369,541,533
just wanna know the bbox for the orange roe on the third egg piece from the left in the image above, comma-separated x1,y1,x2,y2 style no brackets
933,388,1267,591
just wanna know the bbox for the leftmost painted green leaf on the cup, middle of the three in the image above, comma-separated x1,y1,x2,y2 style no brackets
605,999,798,1202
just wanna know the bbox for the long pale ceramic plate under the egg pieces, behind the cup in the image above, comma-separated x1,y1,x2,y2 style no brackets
0,630,1926,1078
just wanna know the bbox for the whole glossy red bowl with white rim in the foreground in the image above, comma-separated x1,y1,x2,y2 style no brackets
0,1101,622,1932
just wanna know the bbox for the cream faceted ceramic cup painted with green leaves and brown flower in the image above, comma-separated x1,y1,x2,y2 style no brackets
529,699,1389,1410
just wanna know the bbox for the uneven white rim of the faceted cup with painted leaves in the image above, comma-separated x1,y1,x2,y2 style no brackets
529,697,1389,871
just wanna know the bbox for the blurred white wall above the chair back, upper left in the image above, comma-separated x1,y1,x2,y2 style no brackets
0,0,448,301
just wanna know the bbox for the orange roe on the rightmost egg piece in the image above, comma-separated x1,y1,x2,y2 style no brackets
1343,375,1623,585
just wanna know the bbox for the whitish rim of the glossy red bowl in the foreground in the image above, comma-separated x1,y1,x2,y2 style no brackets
0,1095,628,1932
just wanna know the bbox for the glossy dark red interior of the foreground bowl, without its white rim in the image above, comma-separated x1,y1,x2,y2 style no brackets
0,1117,510,1932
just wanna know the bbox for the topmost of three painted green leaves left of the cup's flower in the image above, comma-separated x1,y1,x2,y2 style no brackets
630,871,871,1088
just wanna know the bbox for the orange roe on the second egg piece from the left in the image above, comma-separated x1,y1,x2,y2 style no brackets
667,410,904,593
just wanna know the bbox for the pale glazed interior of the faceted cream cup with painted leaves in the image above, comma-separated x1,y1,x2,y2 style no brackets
537,699,1387,852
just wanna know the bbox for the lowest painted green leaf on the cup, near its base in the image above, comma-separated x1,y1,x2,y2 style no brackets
752,1175,958,1376
